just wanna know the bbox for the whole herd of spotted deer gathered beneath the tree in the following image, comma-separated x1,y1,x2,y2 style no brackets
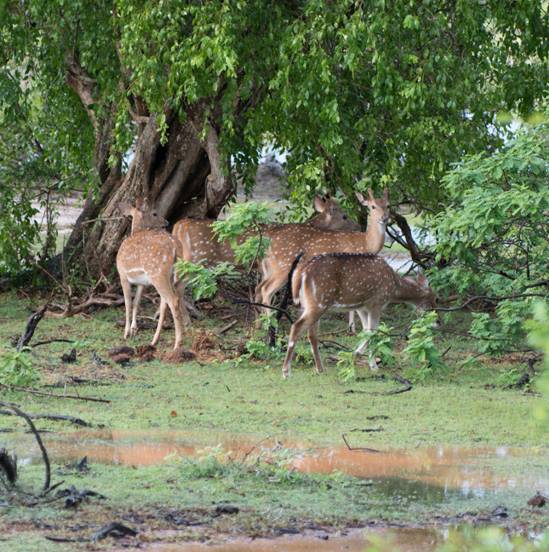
116,189,435,378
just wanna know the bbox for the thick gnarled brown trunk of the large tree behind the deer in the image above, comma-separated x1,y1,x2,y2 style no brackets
64,109,232,279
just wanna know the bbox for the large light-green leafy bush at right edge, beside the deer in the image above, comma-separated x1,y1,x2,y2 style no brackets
427,123,549,353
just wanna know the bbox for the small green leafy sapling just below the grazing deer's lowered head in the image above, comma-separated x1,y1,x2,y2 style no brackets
402,311,445,381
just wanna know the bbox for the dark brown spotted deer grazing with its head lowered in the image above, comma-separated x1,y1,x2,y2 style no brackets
282,253,435,378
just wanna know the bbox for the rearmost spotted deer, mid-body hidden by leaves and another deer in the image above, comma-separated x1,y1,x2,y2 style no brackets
172,196,360,266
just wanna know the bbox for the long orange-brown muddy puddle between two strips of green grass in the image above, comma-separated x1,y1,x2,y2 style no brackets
9,430,549,500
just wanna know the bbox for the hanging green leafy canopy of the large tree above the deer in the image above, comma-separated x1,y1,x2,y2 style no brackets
0,0,546,276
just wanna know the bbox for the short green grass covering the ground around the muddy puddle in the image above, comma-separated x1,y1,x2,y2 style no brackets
0,293,549,550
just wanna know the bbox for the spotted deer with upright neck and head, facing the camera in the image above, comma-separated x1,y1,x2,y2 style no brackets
255,189,389,322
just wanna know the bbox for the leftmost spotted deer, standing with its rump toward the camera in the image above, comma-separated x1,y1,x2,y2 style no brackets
116,200,190,349
